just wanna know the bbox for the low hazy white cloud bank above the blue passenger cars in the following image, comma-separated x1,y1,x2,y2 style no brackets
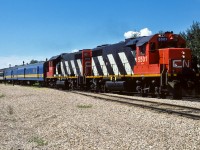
0,56,46,69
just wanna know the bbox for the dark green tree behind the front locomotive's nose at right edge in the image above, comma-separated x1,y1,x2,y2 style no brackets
180,22,200,63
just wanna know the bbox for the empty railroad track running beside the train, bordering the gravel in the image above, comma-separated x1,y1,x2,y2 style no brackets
72,91,200,120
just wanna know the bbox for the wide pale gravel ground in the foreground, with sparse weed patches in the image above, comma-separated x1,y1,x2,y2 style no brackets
0,84,200,150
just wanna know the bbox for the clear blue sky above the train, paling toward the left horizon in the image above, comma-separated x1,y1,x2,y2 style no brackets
0,0,200,68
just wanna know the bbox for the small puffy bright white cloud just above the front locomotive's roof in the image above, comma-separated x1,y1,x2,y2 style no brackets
124,28,152,39
